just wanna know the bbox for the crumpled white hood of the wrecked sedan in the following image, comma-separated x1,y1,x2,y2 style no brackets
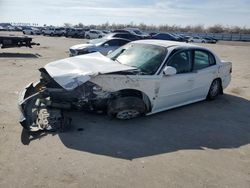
44,52,135,90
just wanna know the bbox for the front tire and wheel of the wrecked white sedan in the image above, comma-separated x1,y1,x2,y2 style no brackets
107,97,146,120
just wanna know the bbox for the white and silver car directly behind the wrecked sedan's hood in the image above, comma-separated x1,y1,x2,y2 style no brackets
69,38,131,56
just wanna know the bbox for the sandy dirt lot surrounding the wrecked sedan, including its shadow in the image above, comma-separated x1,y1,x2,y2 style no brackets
0,33,250,188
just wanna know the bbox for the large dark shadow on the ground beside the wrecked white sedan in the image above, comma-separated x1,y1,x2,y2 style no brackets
20,94,250,160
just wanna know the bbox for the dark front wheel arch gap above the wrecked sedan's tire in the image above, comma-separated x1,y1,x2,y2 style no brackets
113,89,152,112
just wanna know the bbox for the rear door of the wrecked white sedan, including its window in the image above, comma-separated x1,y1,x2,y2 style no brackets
193,49,218,99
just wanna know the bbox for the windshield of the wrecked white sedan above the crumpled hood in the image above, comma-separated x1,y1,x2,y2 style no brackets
108,43,167,75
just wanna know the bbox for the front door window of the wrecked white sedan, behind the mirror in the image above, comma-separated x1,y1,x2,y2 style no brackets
168,51,192,74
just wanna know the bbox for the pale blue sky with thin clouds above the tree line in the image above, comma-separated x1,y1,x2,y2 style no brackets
0,0,250,27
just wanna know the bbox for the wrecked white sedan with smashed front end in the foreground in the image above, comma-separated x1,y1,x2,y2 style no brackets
19,40,232,131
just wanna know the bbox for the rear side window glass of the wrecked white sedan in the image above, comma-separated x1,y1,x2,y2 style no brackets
193,50,215,70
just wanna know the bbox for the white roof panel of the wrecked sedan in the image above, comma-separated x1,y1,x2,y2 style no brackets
133,40,201,49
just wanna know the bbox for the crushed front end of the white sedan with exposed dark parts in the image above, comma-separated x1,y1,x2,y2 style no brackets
18,68,111,131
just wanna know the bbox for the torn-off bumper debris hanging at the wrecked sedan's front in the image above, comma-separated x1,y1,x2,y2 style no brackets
18,83,71,132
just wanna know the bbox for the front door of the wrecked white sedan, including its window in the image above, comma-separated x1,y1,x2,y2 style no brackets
153,50,196,112
